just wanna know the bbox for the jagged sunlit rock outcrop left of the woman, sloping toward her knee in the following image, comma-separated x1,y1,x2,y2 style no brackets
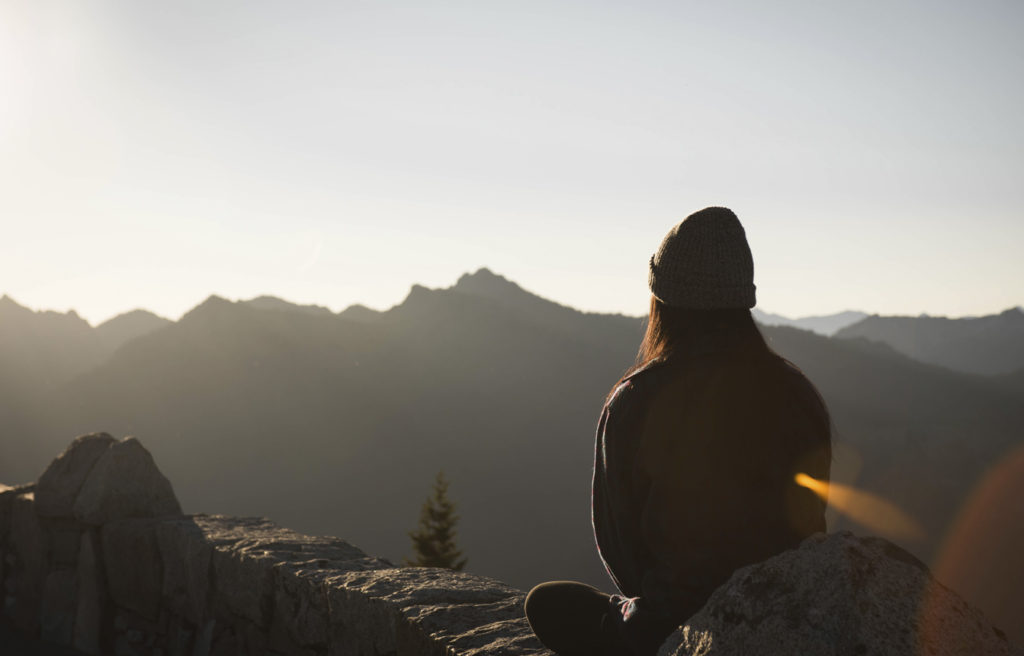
0,434,550,656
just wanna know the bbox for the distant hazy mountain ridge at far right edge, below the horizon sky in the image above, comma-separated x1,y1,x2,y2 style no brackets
836,307,1024,376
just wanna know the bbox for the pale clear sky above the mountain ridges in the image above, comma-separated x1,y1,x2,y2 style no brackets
0,0,1024,323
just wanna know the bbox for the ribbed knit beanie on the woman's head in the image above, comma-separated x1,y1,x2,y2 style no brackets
647,208,756,310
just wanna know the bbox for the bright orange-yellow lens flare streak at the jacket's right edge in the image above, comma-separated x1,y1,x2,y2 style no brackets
794,473,925,540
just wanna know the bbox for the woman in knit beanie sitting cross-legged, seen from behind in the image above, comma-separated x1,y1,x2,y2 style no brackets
525,208,831,656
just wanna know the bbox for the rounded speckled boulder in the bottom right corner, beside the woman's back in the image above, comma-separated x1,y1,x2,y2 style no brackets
658,531,1024,656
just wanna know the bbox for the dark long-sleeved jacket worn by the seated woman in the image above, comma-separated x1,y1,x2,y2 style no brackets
592,348,831,654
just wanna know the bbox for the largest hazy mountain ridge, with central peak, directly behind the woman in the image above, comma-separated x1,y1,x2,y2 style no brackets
0,269,1024,618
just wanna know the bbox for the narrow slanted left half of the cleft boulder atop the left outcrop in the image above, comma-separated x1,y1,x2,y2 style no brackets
36,433,117,517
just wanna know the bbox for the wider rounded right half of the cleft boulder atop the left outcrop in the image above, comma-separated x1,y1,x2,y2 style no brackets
74,437,181,526
